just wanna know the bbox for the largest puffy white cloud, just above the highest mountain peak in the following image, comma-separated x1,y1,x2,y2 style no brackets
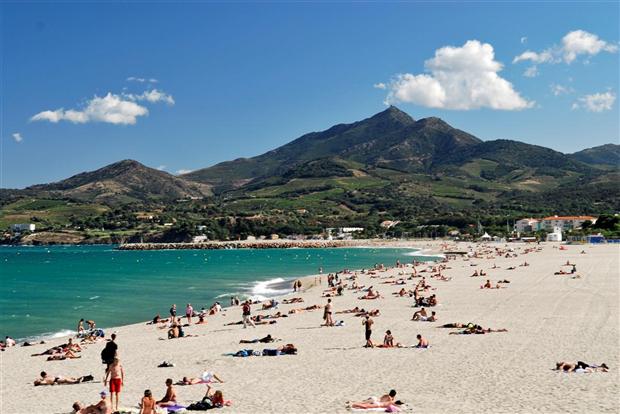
386,40,534,110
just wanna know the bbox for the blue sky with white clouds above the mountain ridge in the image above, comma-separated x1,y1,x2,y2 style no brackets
0,2,620,188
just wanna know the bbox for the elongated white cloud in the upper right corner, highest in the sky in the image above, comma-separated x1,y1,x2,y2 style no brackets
512,30,618,76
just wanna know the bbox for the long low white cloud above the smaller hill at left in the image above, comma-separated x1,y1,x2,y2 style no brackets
30,92,149,125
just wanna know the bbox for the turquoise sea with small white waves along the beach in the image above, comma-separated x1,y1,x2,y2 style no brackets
0,246,432,339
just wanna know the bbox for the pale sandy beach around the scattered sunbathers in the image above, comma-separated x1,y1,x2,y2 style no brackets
0,244,620,414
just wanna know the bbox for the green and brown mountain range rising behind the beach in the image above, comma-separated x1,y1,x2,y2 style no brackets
0,106,620,233
